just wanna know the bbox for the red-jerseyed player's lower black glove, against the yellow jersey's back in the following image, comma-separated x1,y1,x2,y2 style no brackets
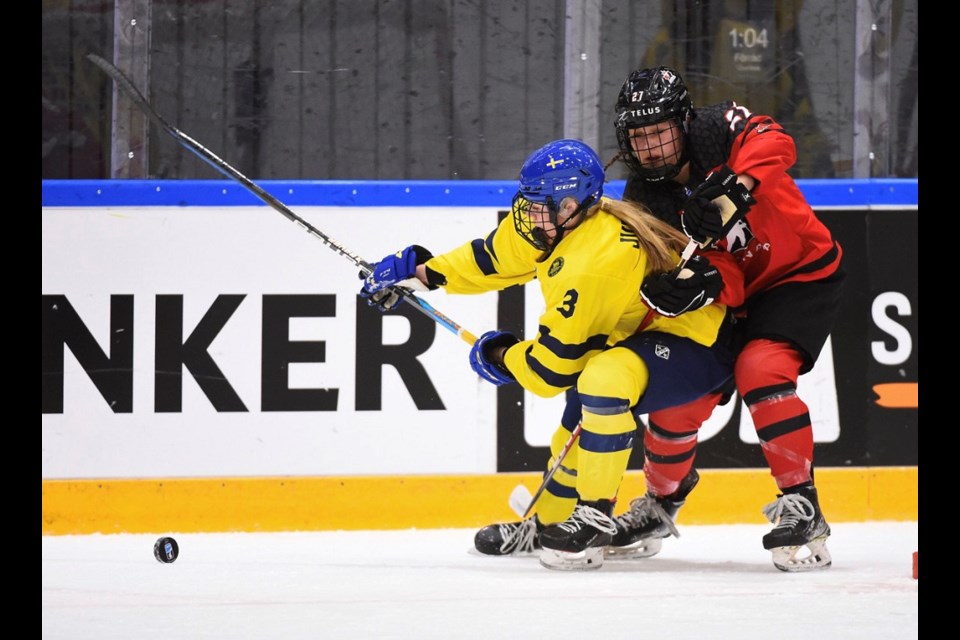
640,255,723,318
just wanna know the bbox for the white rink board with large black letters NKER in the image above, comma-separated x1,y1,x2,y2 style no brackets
41,207,497,479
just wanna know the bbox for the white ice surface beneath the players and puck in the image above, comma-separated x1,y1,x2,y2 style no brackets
41,522,919,640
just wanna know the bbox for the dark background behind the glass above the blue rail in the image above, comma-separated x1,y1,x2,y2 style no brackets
41,0,919,180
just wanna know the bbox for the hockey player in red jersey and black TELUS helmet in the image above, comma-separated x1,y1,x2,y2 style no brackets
607,67,844,571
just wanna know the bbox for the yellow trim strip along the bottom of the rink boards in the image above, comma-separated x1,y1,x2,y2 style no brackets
41,467,919,535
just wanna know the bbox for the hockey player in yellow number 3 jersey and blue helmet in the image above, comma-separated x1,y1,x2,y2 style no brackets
360,140,732,569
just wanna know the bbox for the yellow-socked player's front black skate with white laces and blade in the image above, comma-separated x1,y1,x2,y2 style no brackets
540,500,617,570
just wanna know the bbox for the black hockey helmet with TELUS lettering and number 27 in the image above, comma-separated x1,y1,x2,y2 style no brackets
615,67,693,182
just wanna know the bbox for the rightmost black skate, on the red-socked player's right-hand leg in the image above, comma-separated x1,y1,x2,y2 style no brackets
763,486,833,572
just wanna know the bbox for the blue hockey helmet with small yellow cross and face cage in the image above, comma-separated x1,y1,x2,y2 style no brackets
513,139,604,251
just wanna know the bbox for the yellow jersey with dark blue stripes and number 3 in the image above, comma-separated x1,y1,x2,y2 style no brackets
427,205,726,398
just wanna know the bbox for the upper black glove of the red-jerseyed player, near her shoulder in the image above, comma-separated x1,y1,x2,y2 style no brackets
681,165,757,246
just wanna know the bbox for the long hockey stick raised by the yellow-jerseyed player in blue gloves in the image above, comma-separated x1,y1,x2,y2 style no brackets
87,53,477,345
